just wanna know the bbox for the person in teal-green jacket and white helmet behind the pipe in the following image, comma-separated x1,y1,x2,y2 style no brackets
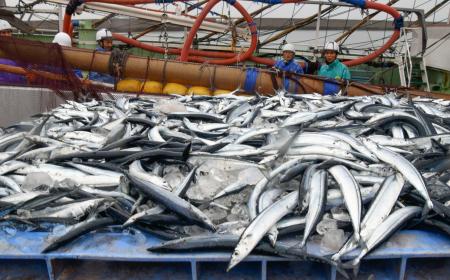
319,42,351,80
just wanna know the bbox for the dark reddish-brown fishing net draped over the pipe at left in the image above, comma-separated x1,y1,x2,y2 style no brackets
0,37,110,101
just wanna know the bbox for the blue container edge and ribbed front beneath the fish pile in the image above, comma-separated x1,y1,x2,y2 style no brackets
0,230,450,280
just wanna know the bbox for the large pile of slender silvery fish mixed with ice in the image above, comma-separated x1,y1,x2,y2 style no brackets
0,92,450,273
